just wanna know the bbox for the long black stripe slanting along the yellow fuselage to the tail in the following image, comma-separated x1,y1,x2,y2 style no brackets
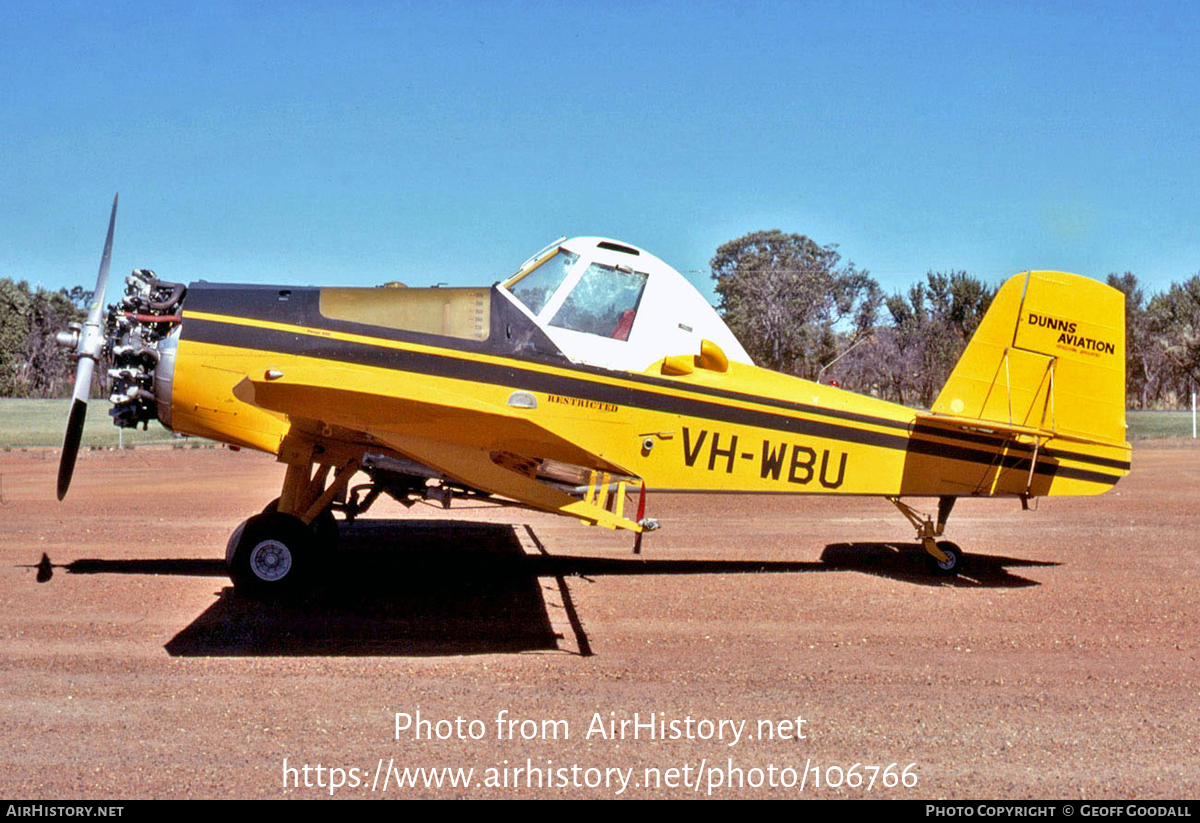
182,316,1120,485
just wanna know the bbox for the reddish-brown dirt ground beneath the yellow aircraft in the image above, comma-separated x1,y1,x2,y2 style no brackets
0,445,1200,799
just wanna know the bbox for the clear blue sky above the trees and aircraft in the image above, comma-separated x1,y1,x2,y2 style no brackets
0,0,1200,303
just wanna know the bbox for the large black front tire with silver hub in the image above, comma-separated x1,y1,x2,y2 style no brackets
229,511,317,597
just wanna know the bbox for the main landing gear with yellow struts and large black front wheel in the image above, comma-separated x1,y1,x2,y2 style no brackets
226,447,359,596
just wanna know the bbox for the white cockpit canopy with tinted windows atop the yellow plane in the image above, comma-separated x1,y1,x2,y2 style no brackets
498,238,751,371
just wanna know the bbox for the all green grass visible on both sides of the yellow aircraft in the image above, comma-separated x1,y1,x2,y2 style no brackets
0,397,1185,449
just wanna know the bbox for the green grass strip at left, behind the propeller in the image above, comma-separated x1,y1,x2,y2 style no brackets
0,397,208,449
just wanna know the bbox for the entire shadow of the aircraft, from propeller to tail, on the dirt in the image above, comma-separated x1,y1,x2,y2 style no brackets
25,519,1057,656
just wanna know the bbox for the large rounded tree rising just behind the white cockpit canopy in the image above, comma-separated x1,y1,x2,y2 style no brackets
709,229,882,378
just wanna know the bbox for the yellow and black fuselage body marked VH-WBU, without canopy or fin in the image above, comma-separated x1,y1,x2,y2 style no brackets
160,282,1129,495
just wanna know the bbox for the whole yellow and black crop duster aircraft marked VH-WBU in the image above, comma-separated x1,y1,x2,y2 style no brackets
58,199,1130,594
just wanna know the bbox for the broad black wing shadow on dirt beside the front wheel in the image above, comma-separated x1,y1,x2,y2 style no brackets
164,521,566,656
